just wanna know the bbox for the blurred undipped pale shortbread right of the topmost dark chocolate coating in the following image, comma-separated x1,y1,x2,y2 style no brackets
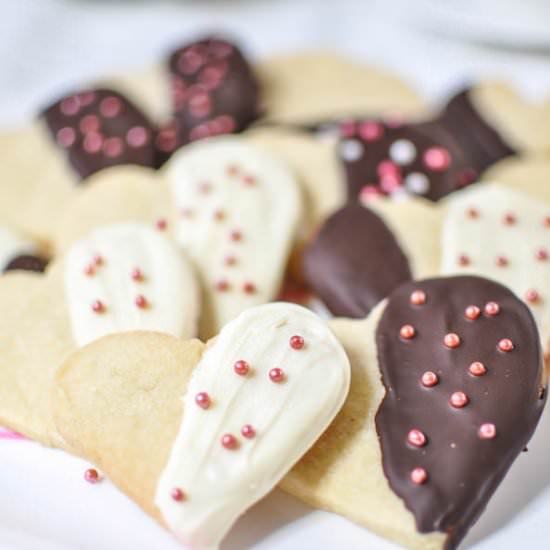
255,52,426,124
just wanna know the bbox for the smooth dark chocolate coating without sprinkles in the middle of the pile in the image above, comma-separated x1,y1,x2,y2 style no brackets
303,203,411,318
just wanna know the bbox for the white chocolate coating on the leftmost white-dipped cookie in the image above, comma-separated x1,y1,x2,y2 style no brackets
65,223,199,346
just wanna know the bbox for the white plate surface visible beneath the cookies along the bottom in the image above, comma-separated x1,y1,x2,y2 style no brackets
0,404,550,550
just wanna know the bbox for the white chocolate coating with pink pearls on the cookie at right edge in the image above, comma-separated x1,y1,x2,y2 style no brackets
441,184,550,350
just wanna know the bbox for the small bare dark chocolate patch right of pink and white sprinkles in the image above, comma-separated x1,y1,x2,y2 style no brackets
438,89,515,173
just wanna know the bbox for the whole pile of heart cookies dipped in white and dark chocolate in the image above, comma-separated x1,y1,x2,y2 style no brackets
0,37,550,550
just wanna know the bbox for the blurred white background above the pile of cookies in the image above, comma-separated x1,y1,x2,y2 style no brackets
0,0,550,125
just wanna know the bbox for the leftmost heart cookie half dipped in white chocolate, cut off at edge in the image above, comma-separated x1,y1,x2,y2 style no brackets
0,224,199,446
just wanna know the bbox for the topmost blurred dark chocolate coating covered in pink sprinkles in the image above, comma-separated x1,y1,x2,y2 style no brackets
157,37,258,157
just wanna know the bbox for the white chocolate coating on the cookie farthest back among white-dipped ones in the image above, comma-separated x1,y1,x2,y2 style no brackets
167,137,301,338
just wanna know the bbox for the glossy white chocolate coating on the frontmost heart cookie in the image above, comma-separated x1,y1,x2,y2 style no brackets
155,303,350,549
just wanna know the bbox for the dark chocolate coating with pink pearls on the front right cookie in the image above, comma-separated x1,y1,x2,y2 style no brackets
375,277,545,549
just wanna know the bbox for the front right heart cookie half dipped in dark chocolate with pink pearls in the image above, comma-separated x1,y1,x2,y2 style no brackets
282,277,546,550
